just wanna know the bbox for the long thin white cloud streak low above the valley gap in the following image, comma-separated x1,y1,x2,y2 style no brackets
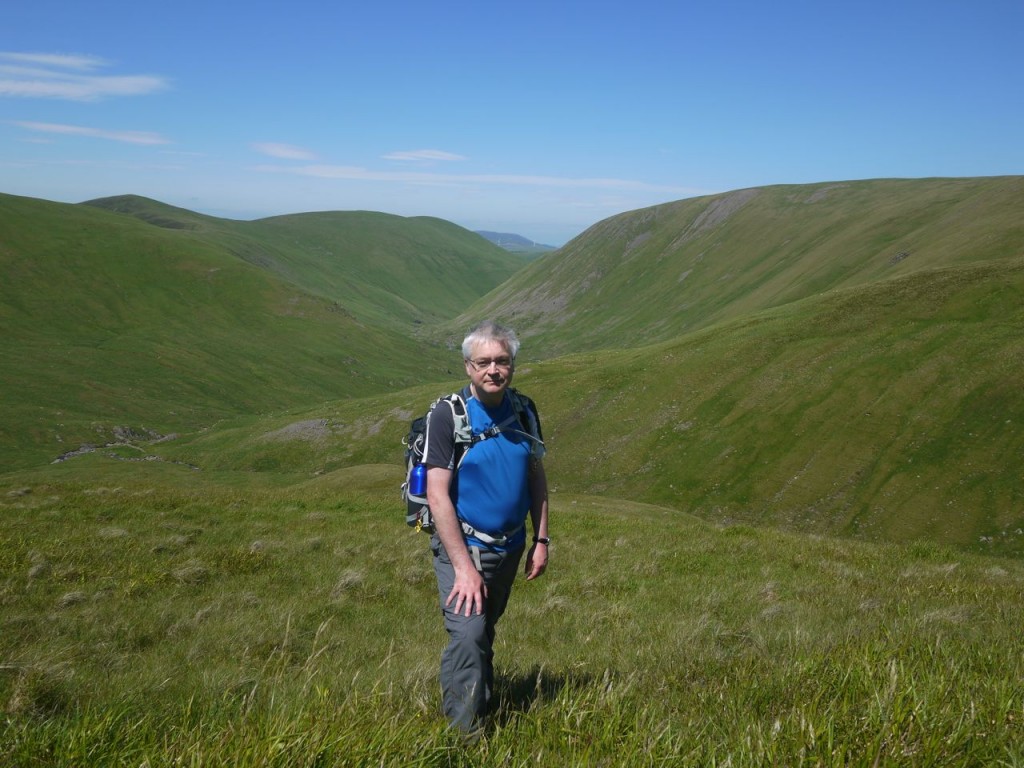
255,165,695,195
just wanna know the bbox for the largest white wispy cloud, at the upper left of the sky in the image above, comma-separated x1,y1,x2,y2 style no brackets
0,51,168,101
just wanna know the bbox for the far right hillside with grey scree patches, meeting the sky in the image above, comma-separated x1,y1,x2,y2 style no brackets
457,176,1024,356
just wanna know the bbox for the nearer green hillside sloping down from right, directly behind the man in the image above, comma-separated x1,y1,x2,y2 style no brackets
116,259,1024,553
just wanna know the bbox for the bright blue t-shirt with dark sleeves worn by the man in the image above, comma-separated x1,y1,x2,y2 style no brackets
425,395,536,550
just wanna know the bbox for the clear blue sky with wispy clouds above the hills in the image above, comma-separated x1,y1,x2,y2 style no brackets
0,0,1024,245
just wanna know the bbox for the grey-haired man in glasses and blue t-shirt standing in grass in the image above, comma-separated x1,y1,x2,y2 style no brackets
424,322,549,733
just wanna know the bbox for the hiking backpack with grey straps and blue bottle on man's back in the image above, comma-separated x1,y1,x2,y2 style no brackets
401,387,545,546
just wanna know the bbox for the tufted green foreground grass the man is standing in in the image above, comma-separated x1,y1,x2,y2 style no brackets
0,457,1024,766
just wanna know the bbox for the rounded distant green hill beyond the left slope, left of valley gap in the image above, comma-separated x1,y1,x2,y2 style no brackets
85,196,525,333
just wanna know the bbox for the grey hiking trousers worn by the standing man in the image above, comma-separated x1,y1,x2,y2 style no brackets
430,534,523,731
